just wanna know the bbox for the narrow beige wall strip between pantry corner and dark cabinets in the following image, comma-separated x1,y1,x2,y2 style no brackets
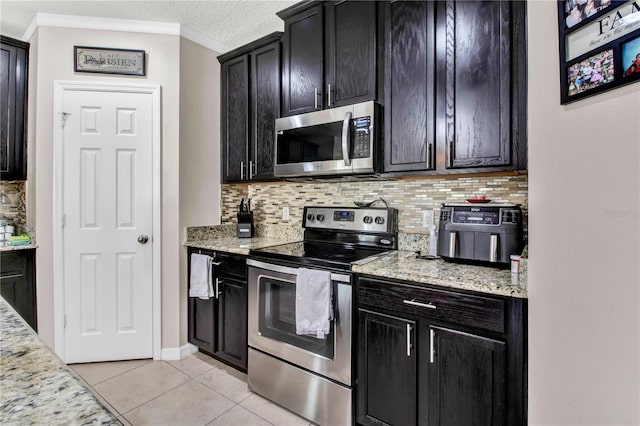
179,35,221,345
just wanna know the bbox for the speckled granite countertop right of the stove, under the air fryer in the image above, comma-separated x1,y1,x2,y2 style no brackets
352,251,527,298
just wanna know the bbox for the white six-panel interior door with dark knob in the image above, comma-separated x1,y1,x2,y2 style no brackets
62,90,153,363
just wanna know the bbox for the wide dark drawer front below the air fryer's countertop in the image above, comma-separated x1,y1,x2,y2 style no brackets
358,279,506,333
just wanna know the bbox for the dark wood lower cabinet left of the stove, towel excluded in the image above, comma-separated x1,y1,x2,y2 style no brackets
187,249,247,371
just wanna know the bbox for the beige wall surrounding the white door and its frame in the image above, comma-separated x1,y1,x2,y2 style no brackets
27,27,183,348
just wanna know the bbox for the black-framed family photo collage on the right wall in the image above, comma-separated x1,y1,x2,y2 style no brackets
558,0,640,104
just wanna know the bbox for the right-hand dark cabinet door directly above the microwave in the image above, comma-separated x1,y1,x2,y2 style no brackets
325,1,376,107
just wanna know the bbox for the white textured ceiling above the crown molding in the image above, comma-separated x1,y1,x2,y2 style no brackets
0,0,297,49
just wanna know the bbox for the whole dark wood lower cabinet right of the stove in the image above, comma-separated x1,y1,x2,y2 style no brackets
356,277,526,426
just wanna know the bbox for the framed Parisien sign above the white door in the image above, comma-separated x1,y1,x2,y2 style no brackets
73,46,145,76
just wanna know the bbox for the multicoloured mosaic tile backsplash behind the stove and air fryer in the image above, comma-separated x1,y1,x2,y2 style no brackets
221,174,529,235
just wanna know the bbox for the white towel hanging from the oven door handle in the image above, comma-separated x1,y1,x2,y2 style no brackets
296,268,333,339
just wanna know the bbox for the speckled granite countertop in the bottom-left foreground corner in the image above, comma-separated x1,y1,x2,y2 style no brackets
0,297,122,425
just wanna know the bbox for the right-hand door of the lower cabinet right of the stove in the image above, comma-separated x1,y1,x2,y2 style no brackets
422,326,506,426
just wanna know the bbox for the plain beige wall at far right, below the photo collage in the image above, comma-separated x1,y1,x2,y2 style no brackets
528,1,640,425
